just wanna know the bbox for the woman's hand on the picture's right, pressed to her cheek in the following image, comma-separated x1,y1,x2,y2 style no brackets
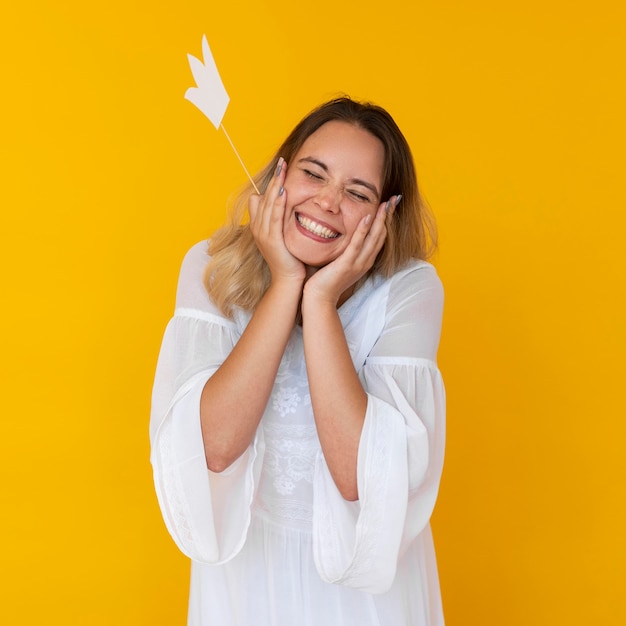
304,196,401,306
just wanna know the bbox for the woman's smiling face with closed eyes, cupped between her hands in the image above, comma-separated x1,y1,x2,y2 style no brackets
284,121,385,267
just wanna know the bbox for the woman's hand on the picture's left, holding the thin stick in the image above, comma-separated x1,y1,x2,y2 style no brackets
248,157,306,281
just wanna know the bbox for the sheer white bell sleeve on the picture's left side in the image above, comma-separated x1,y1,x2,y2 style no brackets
150,243,263,563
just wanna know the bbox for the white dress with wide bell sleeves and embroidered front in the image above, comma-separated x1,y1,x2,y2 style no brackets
150,242,445,626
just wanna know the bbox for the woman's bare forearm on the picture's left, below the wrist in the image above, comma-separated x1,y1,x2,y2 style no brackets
200,281,302,472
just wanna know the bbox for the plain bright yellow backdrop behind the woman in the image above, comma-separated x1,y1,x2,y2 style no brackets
0,0,626,626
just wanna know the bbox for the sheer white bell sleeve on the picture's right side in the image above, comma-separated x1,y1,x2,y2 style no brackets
313,263,445,593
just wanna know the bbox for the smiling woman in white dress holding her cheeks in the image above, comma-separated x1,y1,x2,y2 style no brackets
151,98,445,626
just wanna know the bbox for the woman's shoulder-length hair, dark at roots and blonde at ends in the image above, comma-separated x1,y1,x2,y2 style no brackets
204,97,437,317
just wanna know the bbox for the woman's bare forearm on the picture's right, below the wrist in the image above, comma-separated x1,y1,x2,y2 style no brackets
302,296,367,500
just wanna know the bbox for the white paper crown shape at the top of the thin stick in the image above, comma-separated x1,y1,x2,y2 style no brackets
185,35,230,129
